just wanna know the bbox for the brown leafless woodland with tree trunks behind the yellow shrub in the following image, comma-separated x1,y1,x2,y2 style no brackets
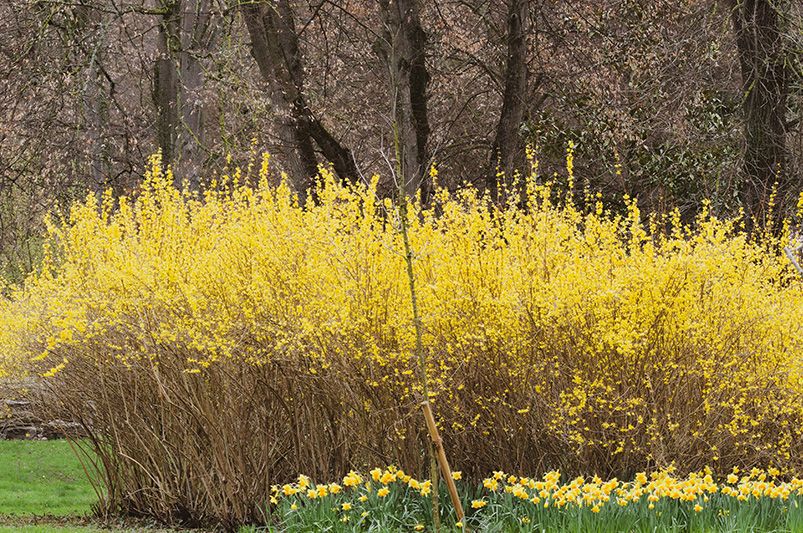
0,0,803,279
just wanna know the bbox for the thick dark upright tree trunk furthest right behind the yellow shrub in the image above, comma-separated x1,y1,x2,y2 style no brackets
731,0,789,221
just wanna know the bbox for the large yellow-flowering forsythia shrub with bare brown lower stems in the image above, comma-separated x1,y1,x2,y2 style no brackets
0,152,803,524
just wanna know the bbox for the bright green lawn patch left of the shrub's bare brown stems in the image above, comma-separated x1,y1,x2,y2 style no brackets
0,440,97,516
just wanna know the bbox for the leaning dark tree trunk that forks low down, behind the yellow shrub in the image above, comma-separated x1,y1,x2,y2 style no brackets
243,0,357,198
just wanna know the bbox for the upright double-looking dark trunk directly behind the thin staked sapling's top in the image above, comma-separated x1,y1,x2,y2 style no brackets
380,0,431,203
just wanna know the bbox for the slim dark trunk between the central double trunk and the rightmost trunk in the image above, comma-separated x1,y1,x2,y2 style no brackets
485,0,530,201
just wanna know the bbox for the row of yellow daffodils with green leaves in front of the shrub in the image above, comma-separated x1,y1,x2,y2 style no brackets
260,466,803,532
